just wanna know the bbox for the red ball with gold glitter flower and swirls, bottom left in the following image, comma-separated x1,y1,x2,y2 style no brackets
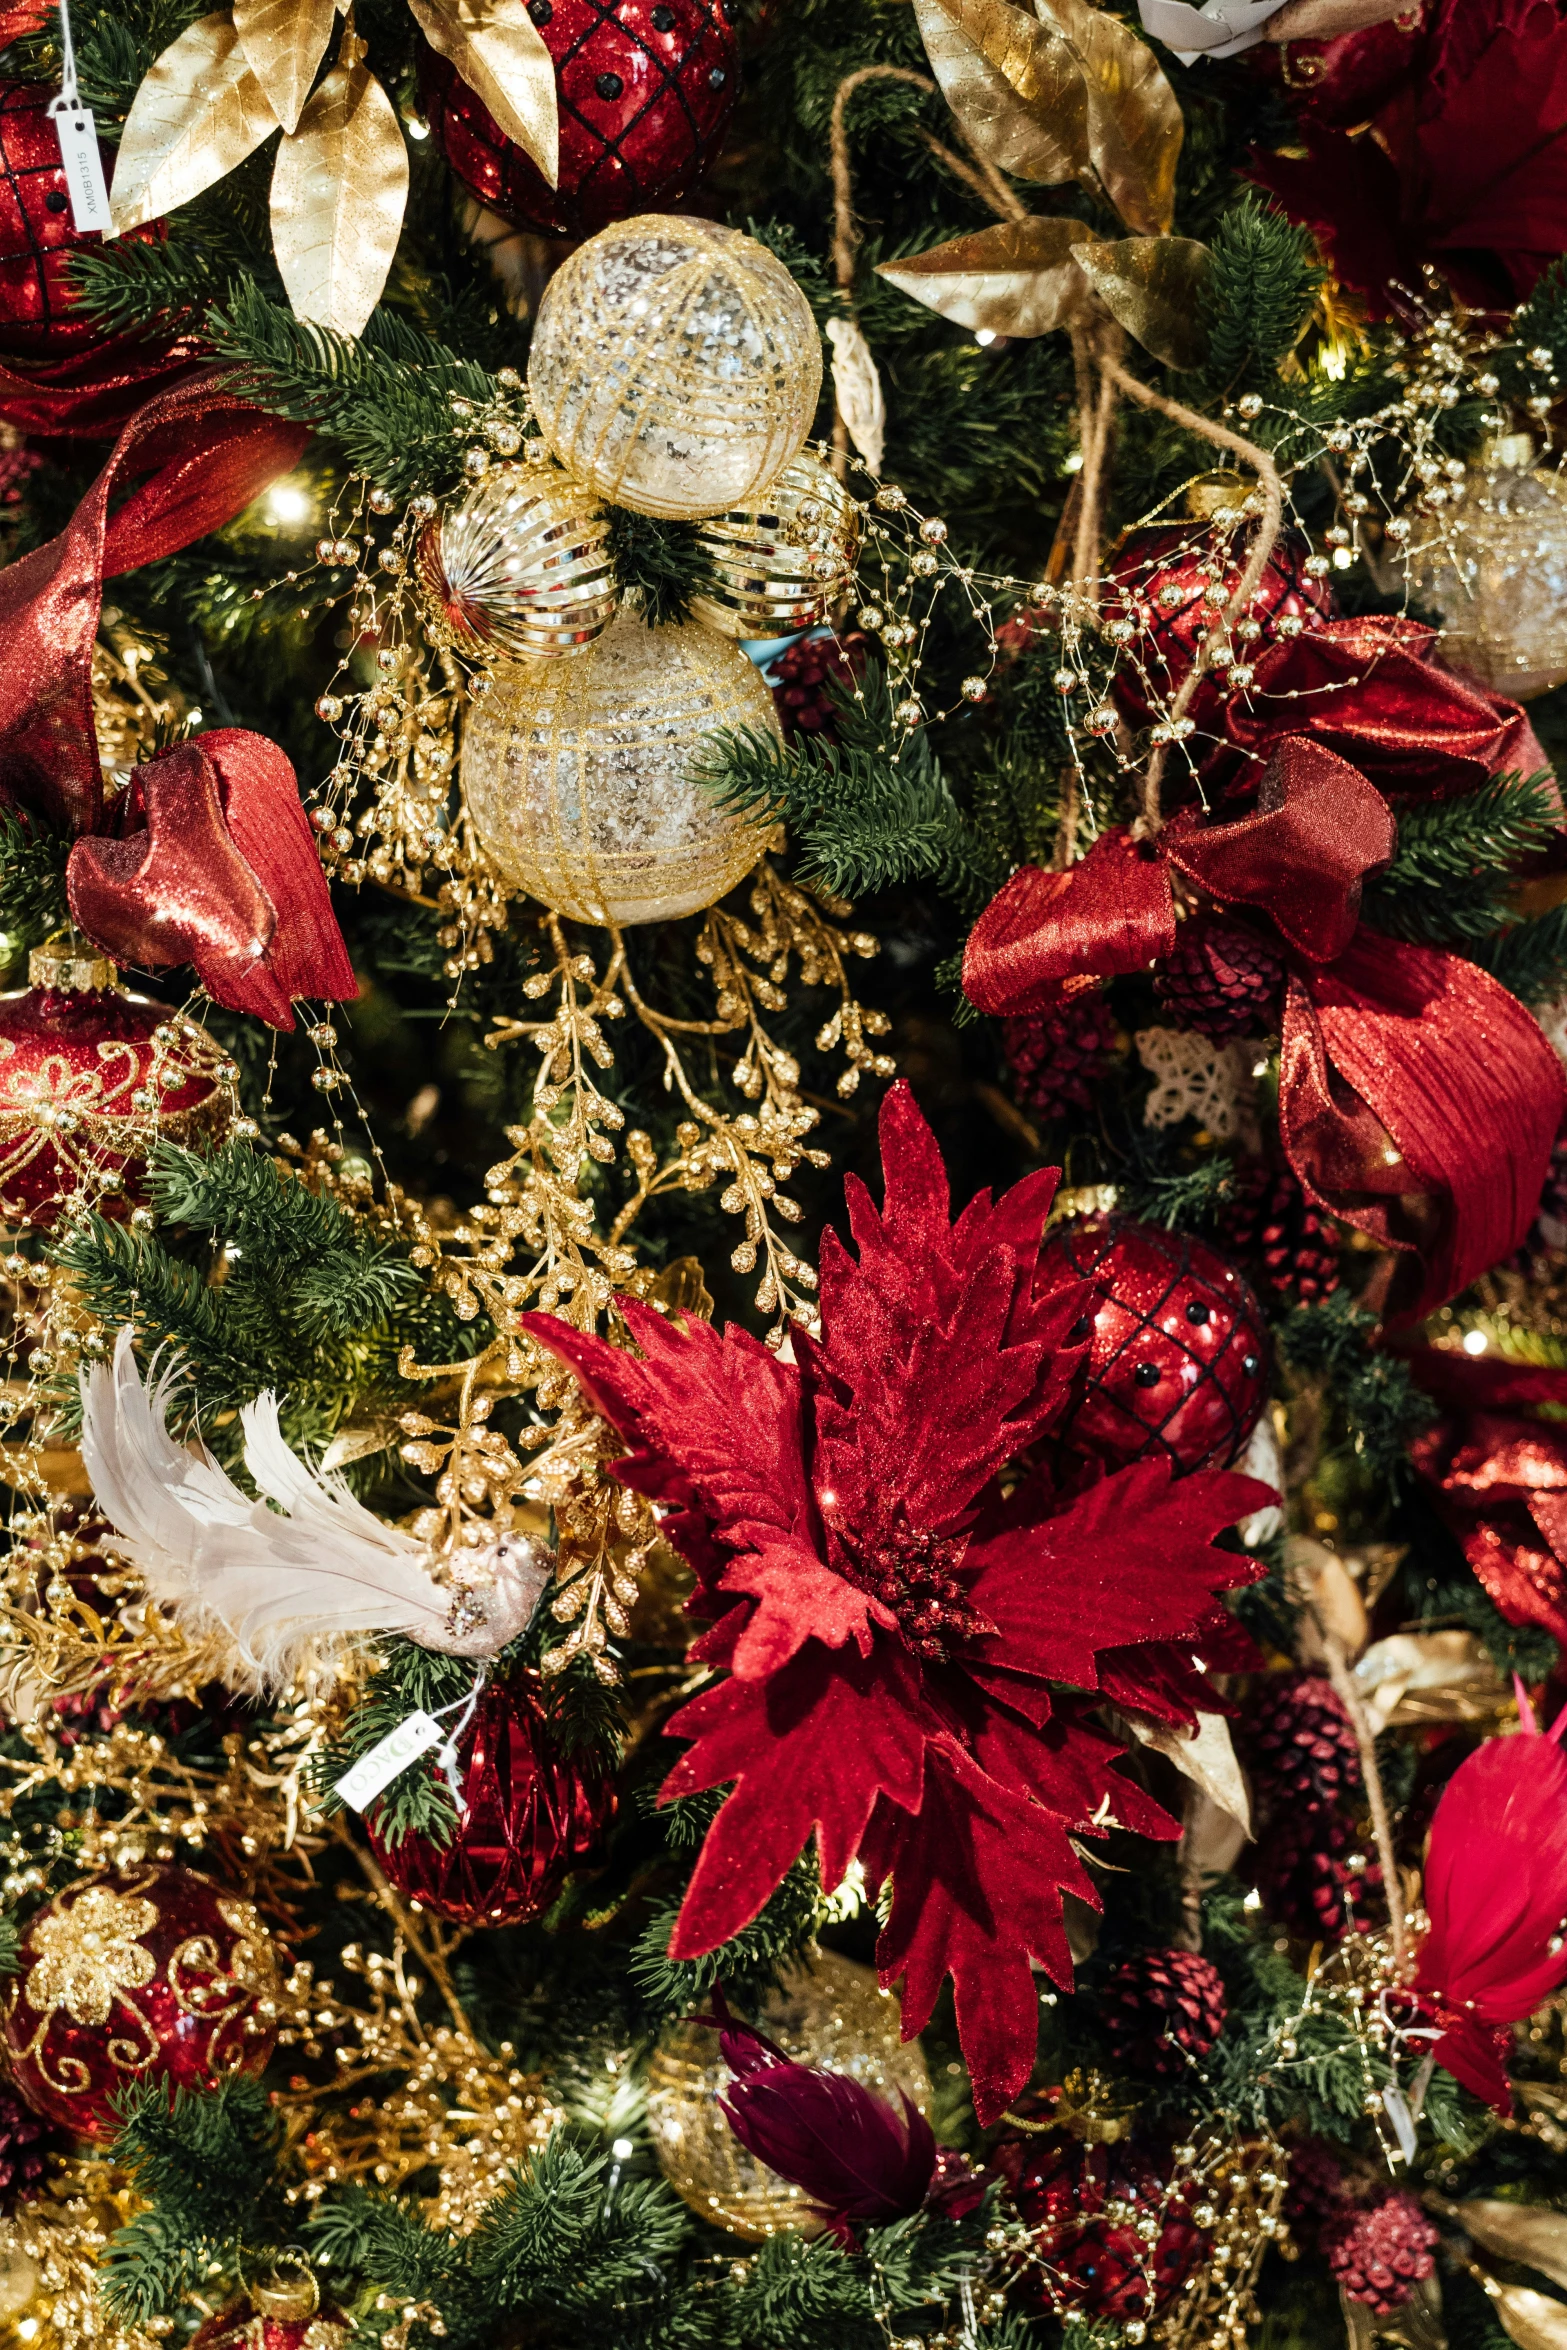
5,1866,277,2141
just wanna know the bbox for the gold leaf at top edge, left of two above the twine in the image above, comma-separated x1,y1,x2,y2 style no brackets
906,0,1088,186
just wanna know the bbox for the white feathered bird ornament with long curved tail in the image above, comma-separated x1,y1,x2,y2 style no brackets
82,1330,550,1690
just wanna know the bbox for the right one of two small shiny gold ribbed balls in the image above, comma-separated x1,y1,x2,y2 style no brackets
691,451,860,637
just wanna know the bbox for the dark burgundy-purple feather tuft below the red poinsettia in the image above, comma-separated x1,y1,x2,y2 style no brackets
709,2012,937,2249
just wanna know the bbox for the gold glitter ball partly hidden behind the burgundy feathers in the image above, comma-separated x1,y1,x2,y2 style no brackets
648,1951,930,2242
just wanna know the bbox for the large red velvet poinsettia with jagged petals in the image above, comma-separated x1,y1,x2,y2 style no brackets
524,1086,1271,2120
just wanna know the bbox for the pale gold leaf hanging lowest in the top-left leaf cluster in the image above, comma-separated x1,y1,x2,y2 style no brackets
273,31,409,336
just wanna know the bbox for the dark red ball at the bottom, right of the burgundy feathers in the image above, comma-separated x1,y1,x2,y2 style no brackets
994,2131,1208,2317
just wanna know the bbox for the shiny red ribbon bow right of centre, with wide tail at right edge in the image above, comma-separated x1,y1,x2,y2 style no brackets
963,736,1567,1318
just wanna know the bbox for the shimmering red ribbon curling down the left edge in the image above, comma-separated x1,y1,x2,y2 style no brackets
0,371,357,1027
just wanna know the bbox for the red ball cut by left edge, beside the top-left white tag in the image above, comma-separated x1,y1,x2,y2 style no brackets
0,82,162,360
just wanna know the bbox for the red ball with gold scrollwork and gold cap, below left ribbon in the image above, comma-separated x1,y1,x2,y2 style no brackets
0,947,230,1227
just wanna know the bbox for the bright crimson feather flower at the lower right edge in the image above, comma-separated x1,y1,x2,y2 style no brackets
1414,1691,1567,2115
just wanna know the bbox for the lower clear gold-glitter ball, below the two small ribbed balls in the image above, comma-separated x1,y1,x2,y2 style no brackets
463,611,778,924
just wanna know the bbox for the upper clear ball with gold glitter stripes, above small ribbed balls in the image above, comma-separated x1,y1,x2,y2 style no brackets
529,212,822,522
